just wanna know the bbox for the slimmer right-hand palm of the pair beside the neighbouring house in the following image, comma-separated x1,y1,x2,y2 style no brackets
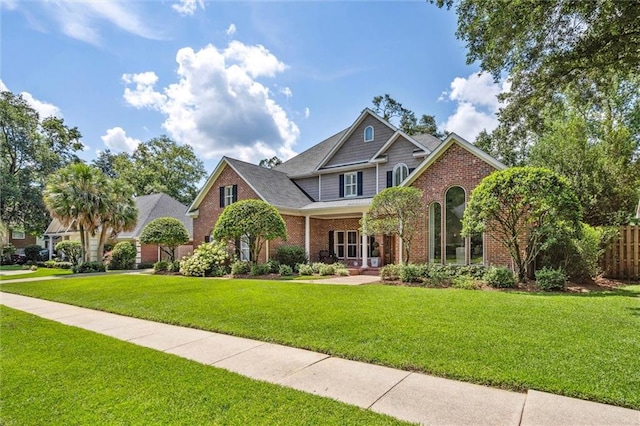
97,179,138,259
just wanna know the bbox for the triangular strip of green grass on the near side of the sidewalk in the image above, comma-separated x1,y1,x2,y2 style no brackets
0,306,408,425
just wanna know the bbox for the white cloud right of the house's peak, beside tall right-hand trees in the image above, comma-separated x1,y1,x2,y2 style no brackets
438,73,511,142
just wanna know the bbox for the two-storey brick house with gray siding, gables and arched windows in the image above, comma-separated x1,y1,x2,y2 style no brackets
188,109,510,266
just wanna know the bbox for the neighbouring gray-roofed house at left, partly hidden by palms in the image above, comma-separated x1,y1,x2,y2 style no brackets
45,194,193,264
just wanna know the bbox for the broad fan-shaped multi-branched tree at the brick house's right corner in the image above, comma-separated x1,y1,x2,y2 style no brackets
462,167,582,282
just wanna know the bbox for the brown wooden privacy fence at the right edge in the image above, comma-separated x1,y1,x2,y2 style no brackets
602,225,640,280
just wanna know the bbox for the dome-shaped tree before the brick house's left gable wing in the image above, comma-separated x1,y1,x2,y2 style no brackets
213,200,287,263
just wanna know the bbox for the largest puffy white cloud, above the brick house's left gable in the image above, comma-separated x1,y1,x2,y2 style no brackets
122,41,300,162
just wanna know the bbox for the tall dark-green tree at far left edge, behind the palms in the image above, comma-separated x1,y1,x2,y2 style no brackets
0,91,83,234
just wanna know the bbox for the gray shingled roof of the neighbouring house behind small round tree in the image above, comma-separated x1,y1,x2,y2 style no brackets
118,194,193,238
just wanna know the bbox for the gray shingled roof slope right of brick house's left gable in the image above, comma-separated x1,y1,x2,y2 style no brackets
225,157,312,208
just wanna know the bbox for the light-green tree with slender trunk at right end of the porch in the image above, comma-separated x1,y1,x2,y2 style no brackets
360,186,424,263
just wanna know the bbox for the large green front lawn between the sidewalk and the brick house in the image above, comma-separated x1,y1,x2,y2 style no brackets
0,275,640,409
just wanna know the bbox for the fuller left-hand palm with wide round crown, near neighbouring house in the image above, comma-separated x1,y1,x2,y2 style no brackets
43,163,109,262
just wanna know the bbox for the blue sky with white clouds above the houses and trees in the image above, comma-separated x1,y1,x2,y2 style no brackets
0,0,506,172
